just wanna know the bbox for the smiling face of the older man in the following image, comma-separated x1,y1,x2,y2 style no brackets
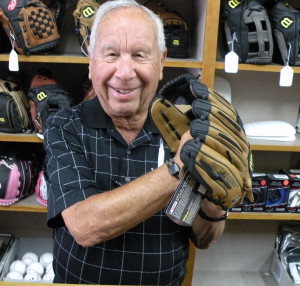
89,8,166,117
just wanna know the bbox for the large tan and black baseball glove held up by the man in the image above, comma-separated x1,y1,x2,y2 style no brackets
150,74,253,210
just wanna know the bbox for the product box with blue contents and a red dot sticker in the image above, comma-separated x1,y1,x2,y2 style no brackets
265,174,290,212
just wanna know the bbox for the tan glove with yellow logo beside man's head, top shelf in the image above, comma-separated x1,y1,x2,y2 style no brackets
73,0,104,56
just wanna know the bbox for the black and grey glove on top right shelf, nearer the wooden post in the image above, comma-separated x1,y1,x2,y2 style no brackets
222,0,273,64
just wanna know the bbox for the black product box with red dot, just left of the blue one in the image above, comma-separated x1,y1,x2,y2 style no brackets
243,173,268,212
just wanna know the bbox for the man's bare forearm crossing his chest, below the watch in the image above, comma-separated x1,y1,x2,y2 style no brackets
62,164,179,247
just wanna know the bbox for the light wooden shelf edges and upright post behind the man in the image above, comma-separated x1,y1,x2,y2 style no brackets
0,0,300,286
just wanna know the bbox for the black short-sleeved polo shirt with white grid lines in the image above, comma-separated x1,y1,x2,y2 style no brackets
44,98,189,285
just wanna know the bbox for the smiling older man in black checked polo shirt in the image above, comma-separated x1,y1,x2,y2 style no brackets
44,0,224,286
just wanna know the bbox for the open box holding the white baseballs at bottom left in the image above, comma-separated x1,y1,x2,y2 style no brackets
0,237,53,285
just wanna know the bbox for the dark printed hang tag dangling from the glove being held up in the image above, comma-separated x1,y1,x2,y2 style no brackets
165,171,205,227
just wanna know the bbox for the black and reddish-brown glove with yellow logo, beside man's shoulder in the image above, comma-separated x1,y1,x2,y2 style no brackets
28,69,73,138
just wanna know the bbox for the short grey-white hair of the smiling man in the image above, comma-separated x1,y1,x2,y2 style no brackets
89,0,166,56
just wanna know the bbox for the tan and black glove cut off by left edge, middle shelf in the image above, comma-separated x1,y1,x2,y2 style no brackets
0,78,31,133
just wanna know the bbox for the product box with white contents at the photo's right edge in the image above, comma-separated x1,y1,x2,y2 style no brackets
280,169,300,213
